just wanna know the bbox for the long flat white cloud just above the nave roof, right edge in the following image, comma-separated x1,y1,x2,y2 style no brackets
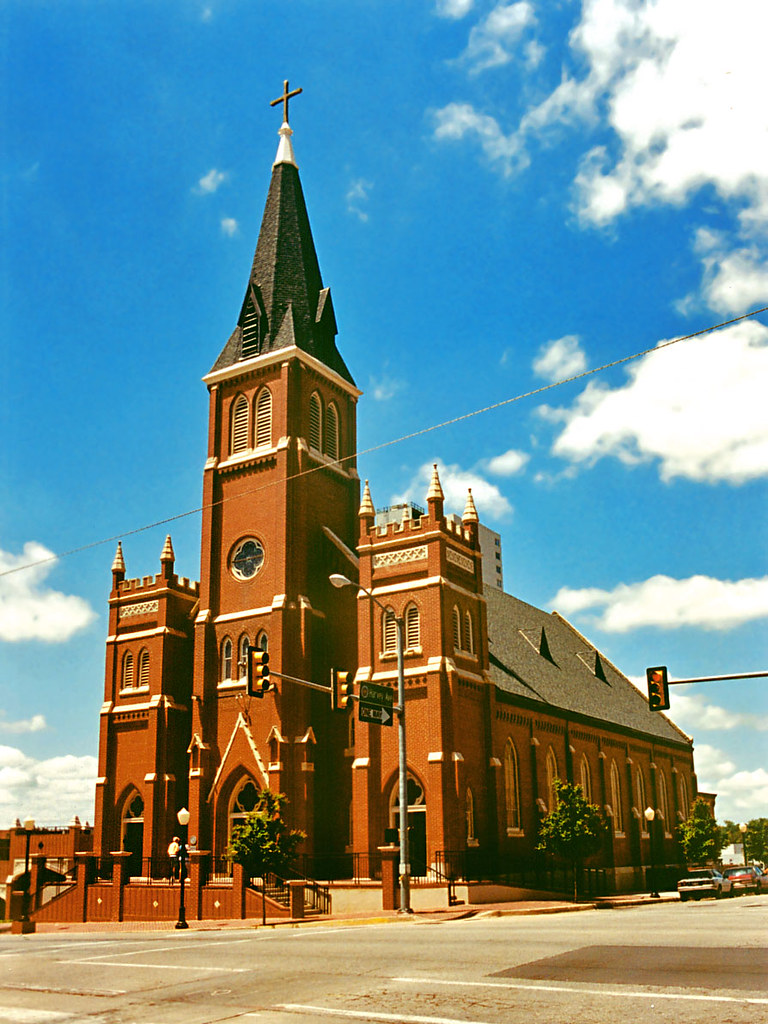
551,575,768,633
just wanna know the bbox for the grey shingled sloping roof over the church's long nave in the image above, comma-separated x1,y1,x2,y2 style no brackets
483,586,691,743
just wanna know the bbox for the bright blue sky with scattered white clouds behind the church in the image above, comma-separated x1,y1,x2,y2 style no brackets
0,0,768,826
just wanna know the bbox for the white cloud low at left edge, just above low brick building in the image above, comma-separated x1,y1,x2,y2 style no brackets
0,745,97,827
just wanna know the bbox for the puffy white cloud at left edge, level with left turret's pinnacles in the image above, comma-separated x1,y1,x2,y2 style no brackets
0,541,96,643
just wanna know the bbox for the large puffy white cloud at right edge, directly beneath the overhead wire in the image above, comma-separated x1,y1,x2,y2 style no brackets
540,321,768,483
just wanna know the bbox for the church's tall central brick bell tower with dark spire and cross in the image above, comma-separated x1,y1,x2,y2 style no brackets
189,82,360,856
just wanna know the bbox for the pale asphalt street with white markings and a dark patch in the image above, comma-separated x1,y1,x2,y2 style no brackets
0,896,768,1024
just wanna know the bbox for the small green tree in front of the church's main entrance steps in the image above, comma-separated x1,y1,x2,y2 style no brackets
226,790,306,924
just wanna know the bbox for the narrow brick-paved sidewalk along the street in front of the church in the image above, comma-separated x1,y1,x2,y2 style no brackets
0,892,678,935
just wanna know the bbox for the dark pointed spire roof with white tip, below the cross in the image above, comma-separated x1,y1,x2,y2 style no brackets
211,125,354,384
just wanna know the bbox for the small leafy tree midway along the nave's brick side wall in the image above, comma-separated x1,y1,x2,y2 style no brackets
537,778,607,902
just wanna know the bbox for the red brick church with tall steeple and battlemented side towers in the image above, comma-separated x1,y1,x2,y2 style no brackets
94,99,696,888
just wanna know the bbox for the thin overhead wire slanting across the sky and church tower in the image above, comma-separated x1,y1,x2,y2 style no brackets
0,306,768,578
